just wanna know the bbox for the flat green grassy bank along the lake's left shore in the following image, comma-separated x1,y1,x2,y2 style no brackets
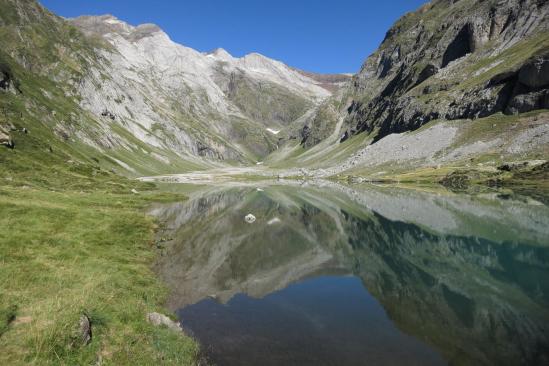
0,186,198,365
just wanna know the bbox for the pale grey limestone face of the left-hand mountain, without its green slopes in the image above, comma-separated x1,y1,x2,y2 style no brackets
66,15,339,161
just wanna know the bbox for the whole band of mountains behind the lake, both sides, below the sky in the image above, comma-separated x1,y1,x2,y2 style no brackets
2,0,549,184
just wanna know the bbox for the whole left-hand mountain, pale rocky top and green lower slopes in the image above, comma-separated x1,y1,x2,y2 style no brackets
0,0,348,182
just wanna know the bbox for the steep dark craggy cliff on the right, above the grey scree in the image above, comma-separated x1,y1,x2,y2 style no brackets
304,0,549,146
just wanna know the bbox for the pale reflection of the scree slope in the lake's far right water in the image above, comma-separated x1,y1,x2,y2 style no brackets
342,184,549,246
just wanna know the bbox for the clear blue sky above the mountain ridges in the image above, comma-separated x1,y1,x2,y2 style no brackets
40,0,426,73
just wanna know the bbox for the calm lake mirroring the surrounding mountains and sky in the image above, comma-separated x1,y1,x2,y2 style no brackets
153,184,549,366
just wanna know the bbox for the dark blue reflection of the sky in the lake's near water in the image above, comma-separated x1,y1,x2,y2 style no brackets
178,276,444,365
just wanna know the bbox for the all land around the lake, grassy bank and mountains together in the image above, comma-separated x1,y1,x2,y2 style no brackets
0,0,549,365
